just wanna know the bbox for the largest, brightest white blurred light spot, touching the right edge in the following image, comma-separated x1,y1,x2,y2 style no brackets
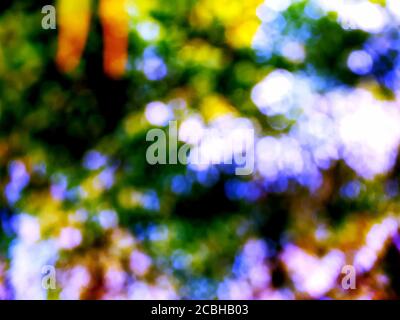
335,90,400,179
